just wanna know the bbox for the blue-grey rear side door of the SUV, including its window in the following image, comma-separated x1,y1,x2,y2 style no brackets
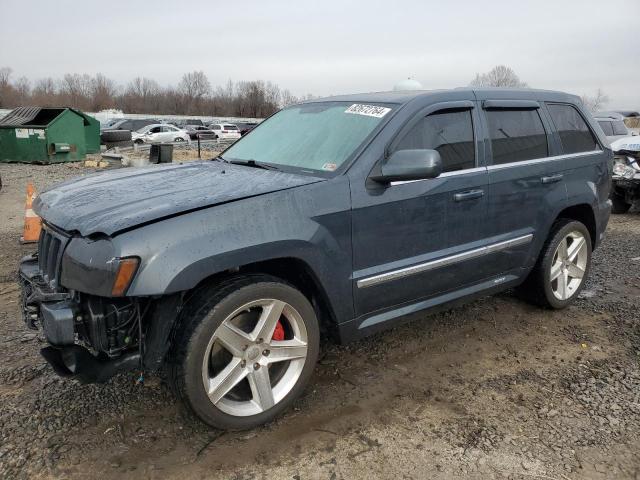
481,98,567,275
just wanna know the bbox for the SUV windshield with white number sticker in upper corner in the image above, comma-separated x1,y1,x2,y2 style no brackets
224,102,392,172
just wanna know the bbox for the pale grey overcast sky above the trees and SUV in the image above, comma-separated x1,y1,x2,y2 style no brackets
0,0,640,109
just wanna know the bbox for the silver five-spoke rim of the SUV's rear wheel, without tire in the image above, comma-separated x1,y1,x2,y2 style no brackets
549,230,589,300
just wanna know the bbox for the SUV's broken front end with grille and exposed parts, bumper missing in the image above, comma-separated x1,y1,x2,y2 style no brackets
19,224,180,383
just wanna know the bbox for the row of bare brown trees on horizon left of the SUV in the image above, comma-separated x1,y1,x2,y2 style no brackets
0,67,312,118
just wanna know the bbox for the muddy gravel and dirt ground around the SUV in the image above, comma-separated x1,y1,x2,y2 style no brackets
0,165,640,480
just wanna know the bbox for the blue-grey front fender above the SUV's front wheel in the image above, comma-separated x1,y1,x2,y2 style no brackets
113,177,353,318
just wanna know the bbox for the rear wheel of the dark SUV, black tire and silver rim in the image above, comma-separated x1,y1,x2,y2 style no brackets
518,218,592,309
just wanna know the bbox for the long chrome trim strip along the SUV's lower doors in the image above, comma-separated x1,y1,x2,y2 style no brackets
357,233,533,288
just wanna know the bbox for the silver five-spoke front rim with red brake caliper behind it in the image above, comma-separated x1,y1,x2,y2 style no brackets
202,299,307,416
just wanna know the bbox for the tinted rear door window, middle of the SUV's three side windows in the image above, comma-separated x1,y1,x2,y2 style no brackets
485,110,549,165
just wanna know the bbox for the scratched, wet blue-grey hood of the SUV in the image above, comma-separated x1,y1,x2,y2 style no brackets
34,161,322,235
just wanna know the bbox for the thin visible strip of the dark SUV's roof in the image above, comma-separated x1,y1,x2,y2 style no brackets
303,87,578,105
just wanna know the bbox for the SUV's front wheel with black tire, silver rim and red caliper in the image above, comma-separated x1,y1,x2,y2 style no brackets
169,275,320,430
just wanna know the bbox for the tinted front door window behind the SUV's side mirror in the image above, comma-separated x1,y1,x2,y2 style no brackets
395,110,476,172
